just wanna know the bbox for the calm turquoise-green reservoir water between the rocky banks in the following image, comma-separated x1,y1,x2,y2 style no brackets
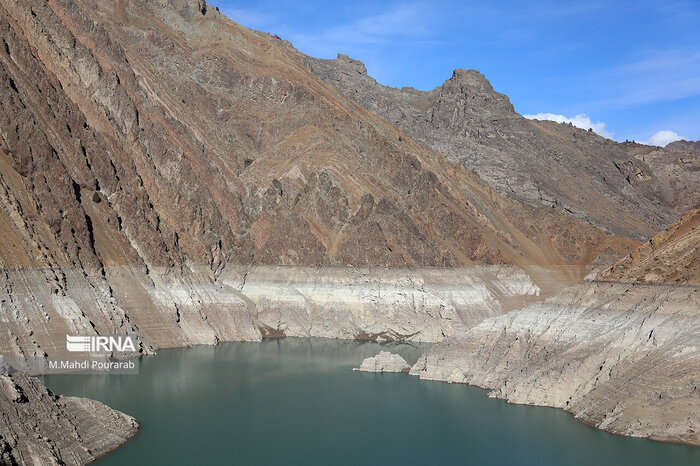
44,339,700,466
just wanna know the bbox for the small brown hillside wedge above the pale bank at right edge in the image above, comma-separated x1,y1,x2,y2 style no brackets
598,209,700,285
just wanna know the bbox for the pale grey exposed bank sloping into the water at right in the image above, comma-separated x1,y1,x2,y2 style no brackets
411,283,700,445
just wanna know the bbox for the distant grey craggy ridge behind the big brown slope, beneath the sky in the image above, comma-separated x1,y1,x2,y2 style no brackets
307,55,700,239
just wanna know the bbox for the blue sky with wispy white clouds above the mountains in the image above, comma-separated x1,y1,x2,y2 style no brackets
210,0,700,144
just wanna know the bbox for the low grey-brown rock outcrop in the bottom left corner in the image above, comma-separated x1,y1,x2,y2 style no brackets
0,374,139,466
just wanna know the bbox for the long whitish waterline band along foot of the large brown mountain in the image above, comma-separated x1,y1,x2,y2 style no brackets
0,266,544,357
